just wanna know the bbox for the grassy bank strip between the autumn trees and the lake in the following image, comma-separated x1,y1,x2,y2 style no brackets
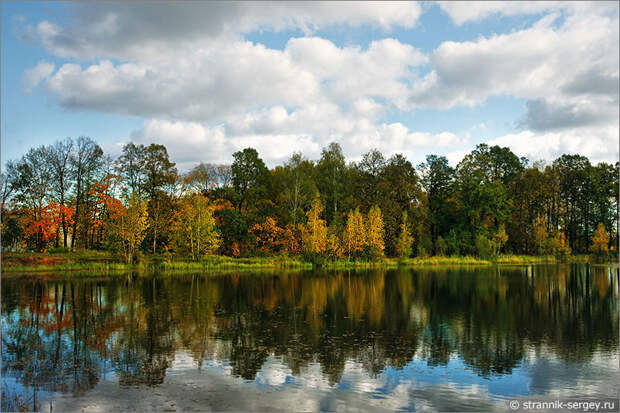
2,251,612,273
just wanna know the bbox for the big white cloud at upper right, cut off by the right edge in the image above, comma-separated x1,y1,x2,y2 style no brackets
410,8,618,109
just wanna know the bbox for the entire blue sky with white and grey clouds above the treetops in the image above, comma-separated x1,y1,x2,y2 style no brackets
0,1,619,171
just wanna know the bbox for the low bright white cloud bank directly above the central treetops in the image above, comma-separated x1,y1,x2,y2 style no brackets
130,116,462,170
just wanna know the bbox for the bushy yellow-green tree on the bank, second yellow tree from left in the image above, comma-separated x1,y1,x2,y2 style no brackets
174,193,220,260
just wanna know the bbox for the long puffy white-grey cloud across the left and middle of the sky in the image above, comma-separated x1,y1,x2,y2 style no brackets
42,38,425,121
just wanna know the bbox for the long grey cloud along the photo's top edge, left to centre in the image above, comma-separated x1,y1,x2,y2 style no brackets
23,1,421,60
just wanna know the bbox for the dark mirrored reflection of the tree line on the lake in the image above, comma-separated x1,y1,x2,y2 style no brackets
2,264,618,411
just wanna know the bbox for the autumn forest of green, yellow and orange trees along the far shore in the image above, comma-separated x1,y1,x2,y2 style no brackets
1,137,619,263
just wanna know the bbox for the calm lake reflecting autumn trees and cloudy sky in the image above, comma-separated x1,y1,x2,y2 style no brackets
2,264,619,411
